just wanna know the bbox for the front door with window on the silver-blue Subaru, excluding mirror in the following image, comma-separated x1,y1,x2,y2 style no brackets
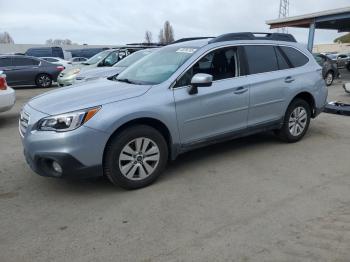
174,47,249,145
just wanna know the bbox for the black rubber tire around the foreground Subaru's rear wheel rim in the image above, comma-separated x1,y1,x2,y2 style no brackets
275,98,311,143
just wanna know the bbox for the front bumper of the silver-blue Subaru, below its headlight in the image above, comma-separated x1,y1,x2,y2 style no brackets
20,105,108,178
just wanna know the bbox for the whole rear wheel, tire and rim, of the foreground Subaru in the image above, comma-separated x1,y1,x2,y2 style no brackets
276,99,311,143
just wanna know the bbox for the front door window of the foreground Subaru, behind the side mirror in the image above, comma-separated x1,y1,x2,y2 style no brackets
175,47,239,87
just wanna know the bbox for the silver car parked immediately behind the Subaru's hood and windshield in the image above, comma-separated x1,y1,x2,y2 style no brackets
75,48,158,83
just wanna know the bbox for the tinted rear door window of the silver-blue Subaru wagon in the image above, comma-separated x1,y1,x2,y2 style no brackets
244,45,278,74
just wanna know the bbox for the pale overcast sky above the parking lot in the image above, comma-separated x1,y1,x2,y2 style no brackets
0,0,350,45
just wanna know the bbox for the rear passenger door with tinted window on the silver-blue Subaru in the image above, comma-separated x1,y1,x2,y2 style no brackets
244,45,293,127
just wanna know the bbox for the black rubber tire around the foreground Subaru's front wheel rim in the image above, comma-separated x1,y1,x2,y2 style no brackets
103,125,168,189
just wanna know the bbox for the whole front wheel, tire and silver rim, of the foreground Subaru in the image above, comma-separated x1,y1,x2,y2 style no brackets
103,125,168,189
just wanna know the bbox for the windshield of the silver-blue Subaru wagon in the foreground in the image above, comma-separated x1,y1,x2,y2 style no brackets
117,47,197,85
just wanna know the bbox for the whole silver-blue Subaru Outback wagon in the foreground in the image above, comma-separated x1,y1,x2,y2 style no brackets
19,33,327,189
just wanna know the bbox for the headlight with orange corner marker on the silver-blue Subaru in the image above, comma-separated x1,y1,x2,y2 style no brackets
38,107,101,132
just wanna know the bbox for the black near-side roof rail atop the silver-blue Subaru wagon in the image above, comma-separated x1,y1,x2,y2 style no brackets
209,32,296,44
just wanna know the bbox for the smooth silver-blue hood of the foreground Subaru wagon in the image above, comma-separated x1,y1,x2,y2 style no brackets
28,79,151,115
